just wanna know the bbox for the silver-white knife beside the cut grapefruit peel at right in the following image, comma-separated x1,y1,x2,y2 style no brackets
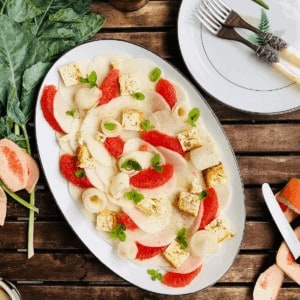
262,183,300,260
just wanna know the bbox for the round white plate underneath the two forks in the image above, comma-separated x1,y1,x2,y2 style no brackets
178,0,300,114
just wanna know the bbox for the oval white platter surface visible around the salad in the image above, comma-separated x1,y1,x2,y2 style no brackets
35,40,245,295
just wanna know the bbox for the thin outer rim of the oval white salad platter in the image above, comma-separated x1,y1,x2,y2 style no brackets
34,38,246,296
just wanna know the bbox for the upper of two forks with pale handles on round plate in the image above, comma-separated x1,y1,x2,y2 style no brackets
203,0,300,66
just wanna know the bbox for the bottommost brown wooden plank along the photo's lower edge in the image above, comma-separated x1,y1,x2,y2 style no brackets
15,285,299,300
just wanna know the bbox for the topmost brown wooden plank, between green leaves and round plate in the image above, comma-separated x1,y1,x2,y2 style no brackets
91,1,180,31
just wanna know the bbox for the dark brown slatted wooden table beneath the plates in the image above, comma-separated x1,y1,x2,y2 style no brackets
0,0,300,300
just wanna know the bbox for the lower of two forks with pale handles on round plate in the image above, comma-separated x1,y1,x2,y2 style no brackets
195,6,300,84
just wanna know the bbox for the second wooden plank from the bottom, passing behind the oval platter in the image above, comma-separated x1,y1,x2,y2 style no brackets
0,253,293,285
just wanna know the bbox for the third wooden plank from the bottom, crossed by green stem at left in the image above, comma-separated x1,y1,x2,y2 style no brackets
0,221,281,251
